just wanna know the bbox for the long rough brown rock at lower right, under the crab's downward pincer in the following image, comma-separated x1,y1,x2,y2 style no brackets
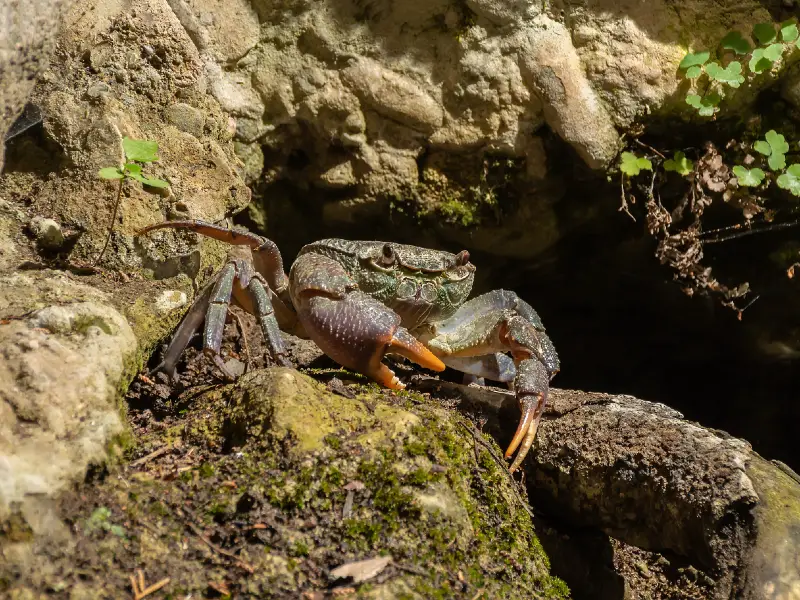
428,384,800,599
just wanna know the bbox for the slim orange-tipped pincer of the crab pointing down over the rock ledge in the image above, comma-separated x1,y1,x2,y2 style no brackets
505,359,550,473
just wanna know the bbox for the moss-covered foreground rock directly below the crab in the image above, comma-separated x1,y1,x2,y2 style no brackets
0,368,569,598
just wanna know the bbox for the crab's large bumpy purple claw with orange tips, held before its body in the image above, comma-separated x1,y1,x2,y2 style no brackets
289,253,445,389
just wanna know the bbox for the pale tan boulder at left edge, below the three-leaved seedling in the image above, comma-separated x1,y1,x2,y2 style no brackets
0,274,137,520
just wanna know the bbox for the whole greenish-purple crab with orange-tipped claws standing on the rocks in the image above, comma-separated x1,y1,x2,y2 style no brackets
137,221,559,471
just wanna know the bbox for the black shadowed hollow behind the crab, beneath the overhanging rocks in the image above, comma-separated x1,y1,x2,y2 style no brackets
239,144,800,468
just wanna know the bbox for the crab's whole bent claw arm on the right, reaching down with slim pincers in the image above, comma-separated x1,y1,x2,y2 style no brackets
425,290,559,471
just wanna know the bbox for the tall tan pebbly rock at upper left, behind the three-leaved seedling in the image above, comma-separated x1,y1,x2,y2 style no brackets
0,0,250,267
